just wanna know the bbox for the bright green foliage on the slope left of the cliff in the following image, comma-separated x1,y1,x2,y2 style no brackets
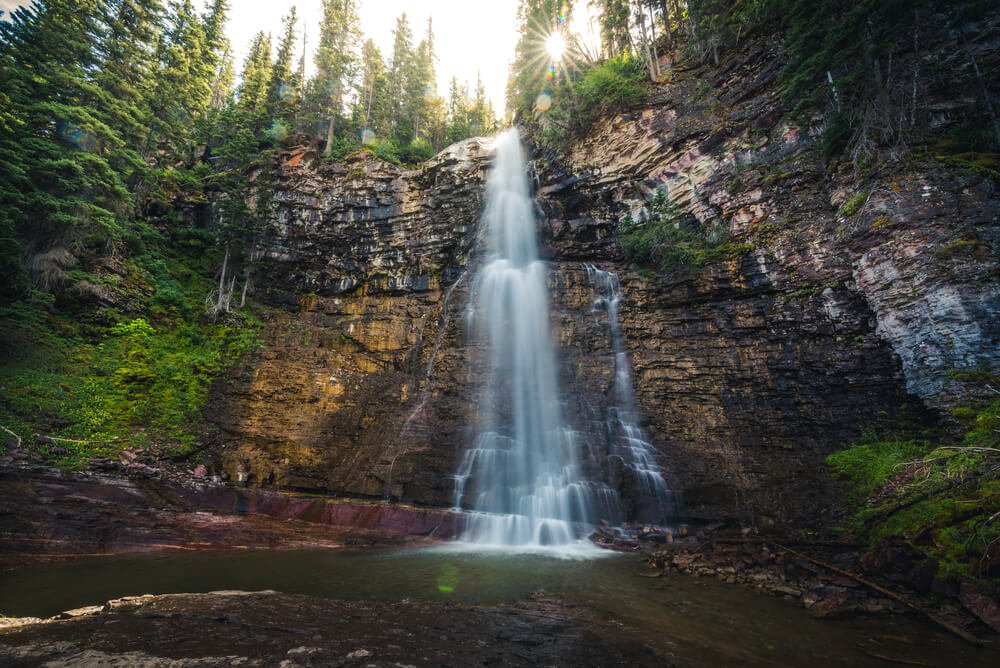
0,247,259,467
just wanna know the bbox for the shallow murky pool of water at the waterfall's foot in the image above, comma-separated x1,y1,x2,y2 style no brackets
0,549,1000,666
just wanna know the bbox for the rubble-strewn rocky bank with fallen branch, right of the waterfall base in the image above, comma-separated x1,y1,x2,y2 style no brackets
592,524,1000,646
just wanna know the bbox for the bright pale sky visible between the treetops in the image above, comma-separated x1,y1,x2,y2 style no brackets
0,0,590,115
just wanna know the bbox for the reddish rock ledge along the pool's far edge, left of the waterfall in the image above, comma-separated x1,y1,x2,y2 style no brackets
0,466,461,568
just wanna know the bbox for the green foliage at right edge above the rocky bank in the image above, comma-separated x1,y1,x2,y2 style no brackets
827,400,1000,576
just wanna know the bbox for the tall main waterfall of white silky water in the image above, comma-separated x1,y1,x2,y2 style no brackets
455,130,617,547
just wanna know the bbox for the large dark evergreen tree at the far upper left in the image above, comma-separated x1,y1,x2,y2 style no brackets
0,0,134,298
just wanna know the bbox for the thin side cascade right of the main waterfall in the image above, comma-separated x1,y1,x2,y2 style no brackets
587,265,677,522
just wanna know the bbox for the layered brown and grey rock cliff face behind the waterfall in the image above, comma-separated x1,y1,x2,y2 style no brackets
210,35,1000,523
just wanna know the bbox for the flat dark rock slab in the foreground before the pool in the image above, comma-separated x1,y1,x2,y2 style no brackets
0,591,665,668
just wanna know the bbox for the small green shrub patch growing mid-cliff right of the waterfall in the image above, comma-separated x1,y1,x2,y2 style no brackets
618,191,744,272
